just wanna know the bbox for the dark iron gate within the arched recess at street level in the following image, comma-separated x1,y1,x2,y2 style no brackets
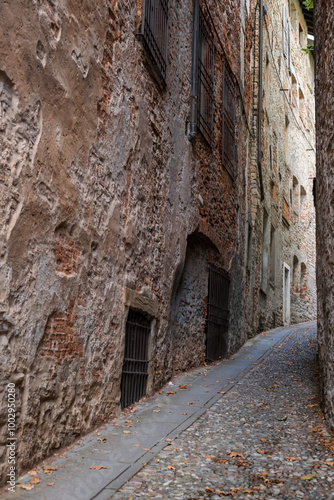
206,265,230,361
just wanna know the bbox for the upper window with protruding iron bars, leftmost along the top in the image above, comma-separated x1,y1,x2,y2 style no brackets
138,0,168,83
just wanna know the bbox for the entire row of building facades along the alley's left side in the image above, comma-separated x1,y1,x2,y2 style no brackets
0,0,315,480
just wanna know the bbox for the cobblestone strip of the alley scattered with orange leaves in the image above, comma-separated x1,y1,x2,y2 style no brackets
112,326,334,500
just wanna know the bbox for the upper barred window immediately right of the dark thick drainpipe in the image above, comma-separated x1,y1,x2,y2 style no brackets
194,7,214,144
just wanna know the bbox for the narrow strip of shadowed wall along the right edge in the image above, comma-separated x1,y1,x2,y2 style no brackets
315,0,334,428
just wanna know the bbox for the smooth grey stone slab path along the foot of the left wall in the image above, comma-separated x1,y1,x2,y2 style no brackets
1,327,308,500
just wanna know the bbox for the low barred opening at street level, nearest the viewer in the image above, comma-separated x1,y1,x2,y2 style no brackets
121,309,151,408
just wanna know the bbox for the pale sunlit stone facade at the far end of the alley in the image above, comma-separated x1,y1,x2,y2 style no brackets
246,1,316,332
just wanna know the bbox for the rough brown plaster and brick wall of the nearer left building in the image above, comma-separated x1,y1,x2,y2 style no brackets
0,0,253,480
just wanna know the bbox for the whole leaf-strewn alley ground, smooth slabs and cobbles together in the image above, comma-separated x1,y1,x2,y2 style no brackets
3,323,334,500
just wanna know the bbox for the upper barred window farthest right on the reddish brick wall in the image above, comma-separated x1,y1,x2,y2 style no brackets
222,64,236,179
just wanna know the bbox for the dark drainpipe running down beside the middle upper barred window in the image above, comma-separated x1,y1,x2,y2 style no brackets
188,0,199,141
